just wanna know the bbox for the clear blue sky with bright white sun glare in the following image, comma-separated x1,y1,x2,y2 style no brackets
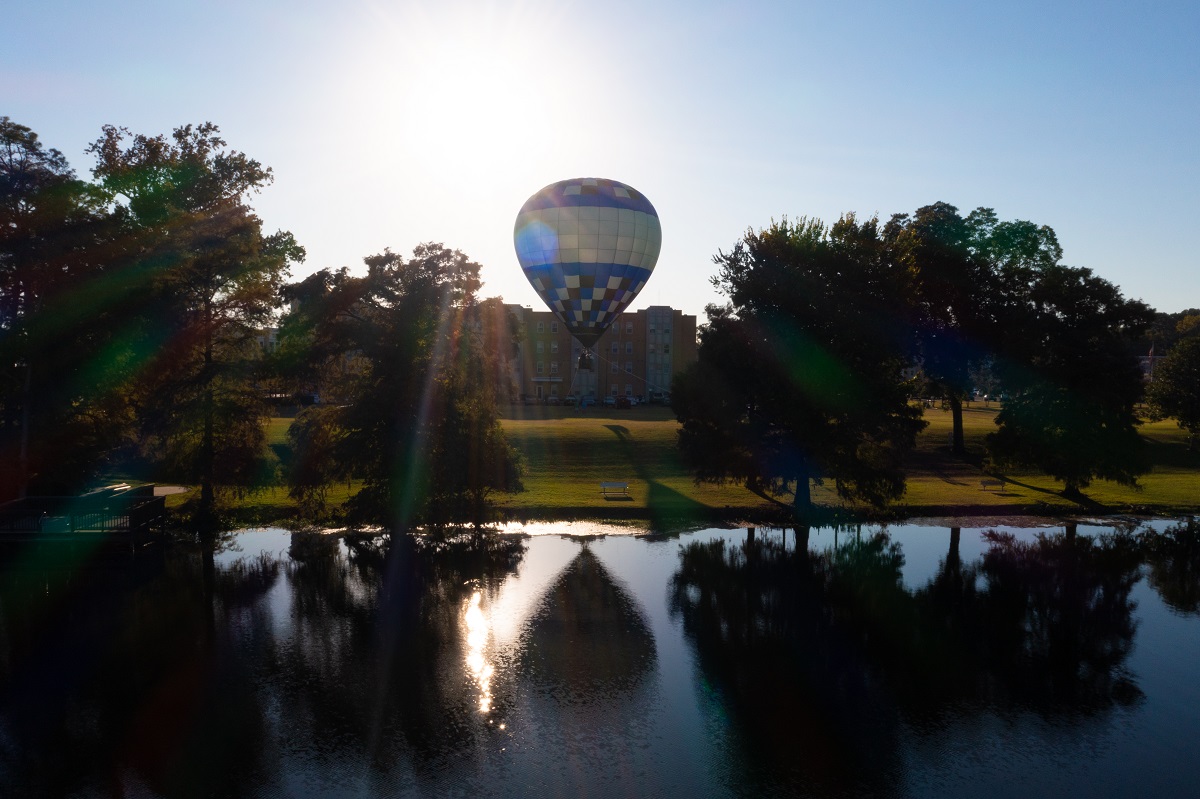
0,0,1200,316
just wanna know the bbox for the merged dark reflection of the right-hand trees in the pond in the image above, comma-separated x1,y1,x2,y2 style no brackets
672,529,1140,794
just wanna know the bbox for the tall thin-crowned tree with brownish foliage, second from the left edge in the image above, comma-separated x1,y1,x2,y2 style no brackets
89,122,304,523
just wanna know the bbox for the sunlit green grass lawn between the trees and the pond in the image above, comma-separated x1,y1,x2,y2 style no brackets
182,403,1200,523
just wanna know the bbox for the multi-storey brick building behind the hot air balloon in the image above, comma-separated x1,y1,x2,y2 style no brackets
504,305,696,400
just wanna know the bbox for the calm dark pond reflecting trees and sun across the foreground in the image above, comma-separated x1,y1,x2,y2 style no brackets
0,521,1200,797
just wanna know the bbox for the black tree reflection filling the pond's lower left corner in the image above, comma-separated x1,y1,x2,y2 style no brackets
0,547,278,797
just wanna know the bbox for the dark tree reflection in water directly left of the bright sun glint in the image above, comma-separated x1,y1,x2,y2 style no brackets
277,536,524,773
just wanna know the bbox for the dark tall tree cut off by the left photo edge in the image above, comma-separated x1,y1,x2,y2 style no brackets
0,116,122,499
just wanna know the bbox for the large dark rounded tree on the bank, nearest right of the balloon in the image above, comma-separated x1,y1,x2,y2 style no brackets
672,216,924,518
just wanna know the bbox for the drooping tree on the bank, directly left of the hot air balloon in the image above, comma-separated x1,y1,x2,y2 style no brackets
284,244,521,530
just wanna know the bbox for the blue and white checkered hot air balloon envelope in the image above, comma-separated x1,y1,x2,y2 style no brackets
512,178,662,348
